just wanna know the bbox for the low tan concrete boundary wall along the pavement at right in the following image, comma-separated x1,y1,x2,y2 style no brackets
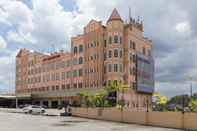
72,108,197,130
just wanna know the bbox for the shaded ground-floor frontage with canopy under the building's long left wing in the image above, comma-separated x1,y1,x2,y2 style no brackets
16,89,101,108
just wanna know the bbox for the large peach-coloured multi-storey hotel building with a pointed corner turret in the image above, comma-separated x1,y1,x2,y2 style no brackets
16,9,154,110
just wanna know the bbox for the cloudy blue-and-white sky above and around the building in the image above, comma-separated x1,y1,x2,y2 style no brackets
0,0,197,97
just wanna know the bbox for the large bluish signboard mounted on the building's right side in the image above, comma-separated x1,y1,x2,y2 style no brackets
136,54,154,93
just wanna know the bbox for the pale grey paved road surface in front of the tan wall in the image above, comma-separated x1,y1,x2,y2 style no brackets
0,112,180,131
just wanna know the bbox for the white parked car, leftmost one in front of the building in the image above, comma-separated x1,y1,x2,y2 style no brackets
23,105,45,114
